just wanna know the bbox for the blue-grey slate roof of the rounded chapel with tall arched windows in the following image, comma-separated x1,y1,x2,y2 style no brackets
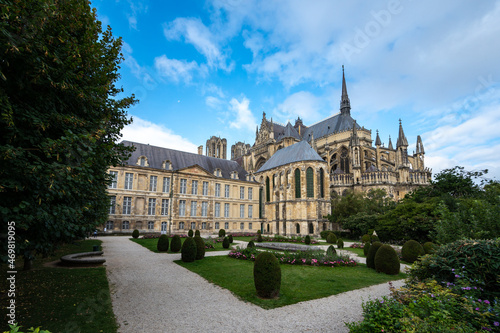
257,141,326,172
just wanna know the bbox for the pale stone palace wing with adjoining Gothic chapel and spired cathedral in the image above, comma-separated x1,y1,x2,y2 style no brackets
103,67,431,235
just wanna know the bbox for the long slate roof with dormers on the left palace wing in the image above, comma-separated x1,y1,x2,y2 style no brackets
117,141,247,180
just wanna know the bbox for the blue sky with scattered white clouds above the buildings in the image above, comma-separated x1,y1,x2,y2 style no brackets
92,0,500,180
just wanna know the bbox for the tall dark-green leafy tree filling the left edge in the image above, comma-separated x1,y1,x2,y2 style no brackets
0,0,135,268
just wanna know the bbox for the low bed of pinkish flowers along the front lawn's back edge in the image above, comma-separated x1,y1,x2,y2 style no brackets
228,247,357,267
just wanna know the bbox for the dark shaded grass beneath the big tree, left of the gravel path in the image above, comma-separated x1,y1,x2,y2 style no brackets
0,239,117,333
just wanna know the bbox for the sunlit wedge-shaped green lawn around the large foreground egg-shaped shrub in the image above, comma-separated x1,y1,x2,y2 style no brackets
176,256,406,309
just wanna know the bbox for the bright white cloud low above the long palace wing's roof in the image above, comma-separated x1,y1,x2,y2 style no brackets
122,116,198,153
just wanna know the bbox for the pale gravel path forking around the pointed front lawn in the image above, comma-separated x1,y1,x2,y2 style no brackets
101,236,403,333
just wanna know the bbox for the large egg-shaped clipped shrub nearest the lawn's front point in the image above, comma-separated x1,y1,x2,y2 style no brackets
253,252,281,298
